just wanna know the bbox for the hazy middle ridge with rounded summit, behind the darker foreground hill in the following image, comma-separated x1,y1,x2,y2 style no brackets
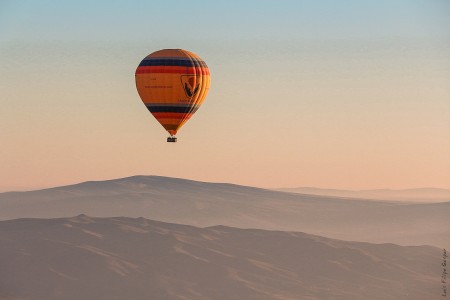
0,176,450,248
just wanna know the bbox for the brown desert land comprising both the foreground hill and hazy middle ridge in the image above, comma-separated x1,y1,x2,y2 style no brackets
0,176,450,300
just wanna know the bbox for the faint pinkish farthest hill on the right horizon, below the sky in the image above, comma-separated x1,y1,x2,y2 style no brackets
276,187,450,203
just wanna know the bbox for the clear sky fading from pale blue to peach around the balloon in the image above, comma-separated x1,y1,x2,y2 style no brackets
0,0,450,191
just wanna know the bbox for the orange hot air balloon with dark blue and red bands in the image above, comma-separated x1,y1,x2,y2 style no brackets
135,49,211,142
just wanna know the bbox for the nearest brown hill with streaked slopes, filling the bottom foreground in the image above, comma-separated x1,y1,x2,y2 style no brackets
0,215,442,300
